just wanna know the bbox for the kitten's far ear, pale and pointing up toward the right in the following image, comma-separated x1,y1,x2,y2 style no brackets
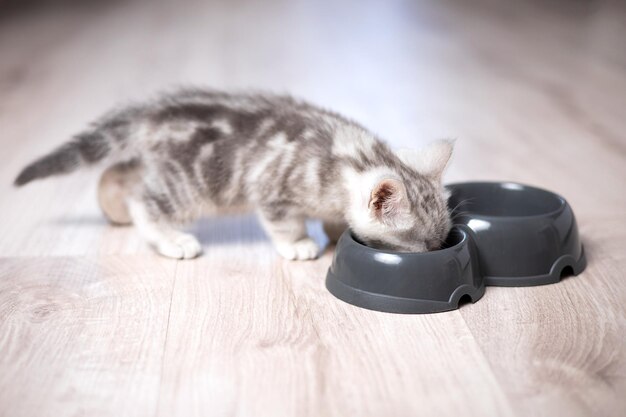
396,140,454,180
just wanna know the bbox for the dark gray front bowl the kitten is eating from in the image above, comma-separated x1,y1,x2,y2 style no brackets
326,228,485,313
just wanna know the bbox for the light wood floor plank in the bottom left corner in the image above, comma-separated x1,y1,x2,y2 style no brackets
0,256,176,417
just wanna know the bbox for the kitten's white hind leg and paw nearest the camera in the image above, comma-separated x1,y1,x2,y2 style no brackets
127,198,202,259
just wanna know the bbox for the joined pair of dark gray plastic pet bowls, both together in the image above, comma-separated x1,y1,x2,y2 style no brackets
326,182,586,313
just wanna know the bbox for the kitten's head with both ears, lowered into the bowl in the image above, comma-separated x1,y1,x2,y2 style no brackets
351,141,453,252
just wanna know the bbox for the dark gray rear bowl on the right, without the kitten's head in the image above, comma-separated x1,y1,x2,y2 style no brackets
447,182,586,286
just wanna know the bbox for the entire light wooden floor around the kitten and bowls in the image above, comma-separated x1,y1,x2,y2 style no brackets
0,0,626,417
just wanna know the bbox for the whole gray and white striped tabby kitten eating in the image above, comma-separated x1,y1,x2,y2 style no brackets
15,89,453,259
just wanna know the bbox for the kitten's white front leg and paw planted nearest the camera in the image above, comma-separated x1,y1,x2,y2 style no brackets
259,212,320,260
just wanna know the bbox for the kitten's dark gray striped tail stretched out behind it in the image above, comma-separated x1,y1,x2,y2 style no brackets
13,115,135,187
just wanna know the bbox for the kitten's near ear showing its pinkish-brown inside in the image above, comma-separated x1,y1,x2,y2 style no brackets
368,178,410,223
